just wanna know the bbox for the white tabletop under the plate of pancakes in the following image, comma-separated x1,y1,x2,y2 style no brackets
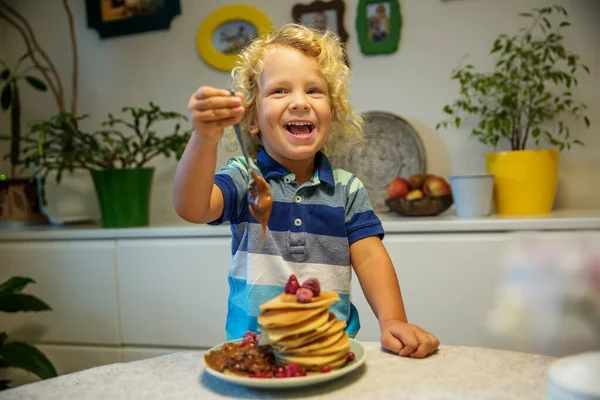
0,342,555,400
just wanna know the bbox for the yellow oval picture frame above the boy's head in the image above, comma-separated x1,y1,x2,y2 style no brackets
196,4,273,71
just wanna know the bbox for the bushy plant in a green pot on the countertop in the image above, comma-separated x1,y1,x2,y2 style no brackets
19,102,191,228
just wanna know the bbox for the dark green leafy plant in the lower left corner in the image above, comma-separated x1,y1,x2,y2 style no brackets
0,276,57,390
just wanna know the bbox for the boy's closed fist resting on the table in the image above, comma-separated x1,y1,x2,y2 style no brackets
381,320,440,358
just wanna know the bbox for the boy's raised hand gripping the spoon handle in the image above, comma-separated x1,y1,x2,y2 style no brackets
188,86,244,143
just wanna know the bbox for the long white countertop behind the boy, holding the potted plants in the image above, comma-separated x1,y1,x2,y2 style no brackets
0,209,600,241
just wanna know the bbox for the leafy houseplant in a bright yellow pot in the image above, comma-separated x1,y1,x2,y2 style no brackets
437,6,590,215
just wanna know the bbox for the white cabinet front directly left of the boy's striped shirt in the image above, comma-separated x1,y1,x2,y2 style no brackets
117,238,231,348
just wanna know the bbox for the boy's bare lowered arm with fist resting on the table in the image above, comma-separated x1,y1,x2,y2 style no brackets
350,236,440,358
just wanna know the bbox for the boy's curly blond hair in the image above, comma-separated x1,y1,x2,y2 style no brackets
231,23,364,157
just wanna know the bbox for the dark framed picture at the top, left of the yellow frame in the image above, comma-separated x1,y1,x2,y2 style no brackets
85,0,181,39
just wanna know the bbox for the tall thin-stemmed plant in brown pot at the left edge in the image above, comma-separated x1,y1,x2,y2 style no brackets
0,53,48,224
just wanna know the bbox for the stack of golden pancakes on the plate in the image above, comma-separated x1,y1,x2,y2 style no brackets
258,292,350,371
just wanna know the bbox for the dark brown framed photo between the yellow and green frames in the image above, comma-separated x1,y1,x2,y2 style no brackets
292,0,348,47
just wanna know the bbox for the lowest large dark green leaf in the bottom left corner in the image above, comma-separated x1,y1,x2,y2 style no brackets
0,342,58,379
